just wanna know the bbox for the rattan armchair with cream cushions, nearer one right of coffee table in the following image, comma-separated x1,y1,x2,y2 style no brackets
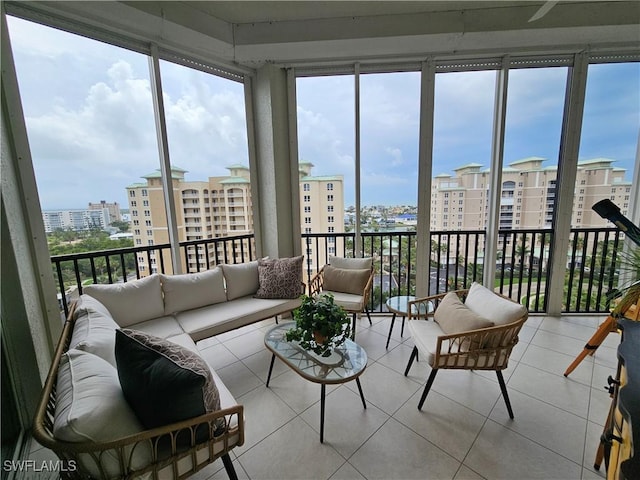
404,284,528,418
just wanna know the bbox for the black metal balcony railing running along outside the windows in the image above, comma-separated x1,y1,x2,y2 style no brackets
51,228,622,314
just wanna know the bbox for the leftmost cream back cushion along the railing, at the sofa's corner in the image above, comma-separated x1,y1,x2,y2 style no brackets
83,274,164,327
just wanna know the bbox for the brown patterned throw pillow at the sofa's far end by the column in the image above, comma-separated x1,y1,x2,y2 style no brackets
255,255,303,298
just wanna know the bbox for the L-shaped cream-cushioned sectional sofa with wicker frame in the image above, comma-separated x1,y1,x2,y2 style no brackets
34,260,304,479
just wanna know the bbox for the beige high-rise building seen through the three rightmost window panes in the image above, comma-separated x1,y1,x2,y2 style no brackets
431,157,631,230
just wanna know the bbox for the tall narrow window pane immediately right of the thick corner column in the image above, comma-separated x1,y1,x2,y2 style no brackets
296,75,355,272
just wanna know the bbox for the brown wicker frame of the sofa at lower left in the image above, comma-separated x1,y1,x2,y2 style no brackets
33,304,244,480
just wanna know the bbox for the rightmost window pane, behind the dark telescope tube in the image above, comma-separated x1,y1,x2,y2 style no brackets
566,63,640,311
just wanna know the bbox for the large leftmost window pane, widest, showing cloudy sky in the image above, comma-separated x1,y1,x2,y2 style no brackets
7,17,164,288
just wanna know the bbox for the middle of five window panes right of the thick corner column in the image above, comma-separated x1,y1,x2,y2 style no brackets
429,71,496,293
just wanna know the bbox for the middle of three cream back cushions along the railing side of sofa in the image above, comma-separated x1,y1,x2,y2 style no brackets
160,267,227,315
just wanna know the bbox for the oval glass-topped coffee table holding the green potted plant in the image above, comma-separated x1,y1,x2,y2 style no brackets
264,322,367,443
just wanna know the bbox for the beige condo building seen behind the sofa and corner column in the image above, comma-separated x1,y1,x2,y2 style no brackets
127,162,344,276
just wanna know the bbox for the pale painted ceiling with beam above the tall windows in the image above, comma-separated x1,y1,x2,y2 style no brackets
4,0,640,68
